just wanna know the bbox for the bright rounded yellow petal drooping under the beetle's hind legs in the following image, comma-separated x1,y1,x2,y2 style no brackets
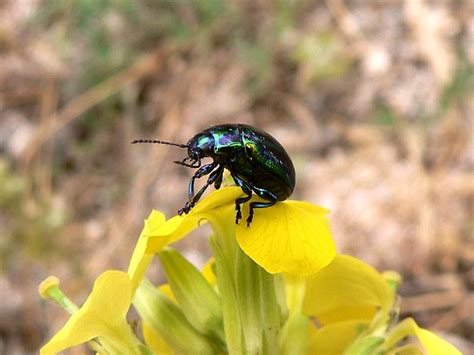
236,201,336,276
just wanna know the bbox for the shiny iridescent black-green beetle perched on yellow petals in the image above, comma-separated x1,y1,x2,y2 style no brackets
132,124,295,227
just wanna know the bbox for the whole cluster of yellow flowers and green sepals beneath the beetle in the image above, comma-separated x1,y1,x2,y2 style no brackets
40,187,460,355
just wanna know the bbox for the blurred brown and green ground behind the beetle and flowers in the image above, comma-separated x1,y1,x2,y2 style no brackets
0,0,474,354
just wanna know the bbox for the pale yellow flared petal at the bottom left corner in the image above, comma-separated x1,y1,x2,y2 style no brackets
41,270,137,354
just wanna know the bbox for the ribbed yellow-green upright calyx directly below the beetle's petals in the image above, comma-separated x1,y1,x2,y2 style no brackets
211,216,281,355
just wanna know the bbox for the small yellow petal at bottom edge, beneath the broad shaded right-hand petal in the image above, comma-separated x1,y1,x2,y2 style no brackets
308,320,369,355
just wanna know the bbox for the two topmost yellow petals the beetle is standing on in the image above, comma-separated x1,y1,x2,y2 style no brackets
129,187,336,285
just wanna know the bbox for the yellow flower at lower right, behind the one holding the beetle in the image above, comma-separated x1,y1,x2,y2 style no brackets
303,255,460,355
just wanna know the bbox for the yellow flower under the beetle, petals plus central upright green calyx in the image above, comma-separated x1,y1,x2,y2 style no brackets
128,187,336,353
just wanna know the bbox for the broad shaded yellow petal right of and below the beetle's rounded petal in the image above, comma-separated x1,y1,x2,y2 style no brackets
303,255,393,324
